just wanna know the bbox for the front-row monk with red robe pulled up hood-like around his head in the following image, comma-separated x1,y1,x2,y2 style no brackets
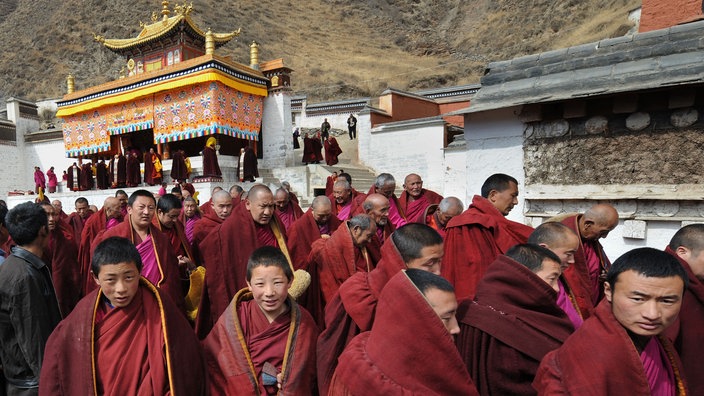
329,269,478,396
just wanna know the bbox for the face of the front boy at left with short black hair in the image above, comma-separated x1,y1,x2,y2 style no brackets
93,262,139,308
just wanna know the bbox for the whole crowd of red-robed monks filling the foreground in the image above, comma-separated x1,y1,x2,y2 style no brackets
0,172,704,395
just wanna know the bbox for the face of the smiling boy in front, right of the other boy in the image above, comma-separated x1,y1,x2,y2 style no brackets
247,265,292,323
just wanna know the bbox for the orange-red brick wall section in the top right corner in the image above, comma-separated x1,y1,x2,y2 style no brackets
640,0,704,32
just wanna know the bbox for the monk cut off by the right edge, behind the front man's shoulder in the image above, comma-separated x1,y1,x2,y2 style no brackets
665,224,704,395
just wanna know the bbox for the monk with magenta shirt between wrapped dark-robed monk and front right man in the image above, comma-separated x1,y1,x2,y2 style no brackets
528,222,594,320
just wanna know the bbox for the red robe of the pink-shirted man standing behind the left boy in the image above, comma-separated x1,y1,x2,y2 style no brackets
87,218,185,312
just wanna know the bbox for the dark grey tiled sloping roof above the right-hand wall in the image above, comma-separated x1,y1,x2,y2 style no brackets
457,21,704,114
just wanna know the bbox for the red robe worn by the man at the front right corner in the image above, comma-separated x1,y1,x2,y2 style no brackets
533,300,685,396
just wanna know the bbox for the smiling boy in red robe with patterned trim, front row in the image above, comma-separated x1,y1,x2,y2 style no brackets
204,246,318,395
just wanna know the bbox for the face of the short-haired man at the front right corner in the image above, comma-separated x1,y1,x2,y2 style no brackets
604,270,684,337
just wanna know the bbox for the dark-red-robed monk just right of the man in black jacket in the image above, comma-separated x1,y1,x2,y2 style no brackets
41,202,83,317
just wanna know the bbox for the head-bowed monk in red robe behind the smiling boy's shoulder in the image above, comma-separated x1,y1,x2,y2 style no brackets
307,214,376,304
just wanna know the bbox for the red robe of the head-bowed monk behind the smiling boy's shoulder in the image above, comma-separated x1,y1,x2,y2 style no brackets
308,222,376,303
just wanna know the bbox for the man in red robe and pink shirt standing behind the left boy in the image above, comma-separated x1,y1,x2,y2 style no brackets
88,190,184,309
